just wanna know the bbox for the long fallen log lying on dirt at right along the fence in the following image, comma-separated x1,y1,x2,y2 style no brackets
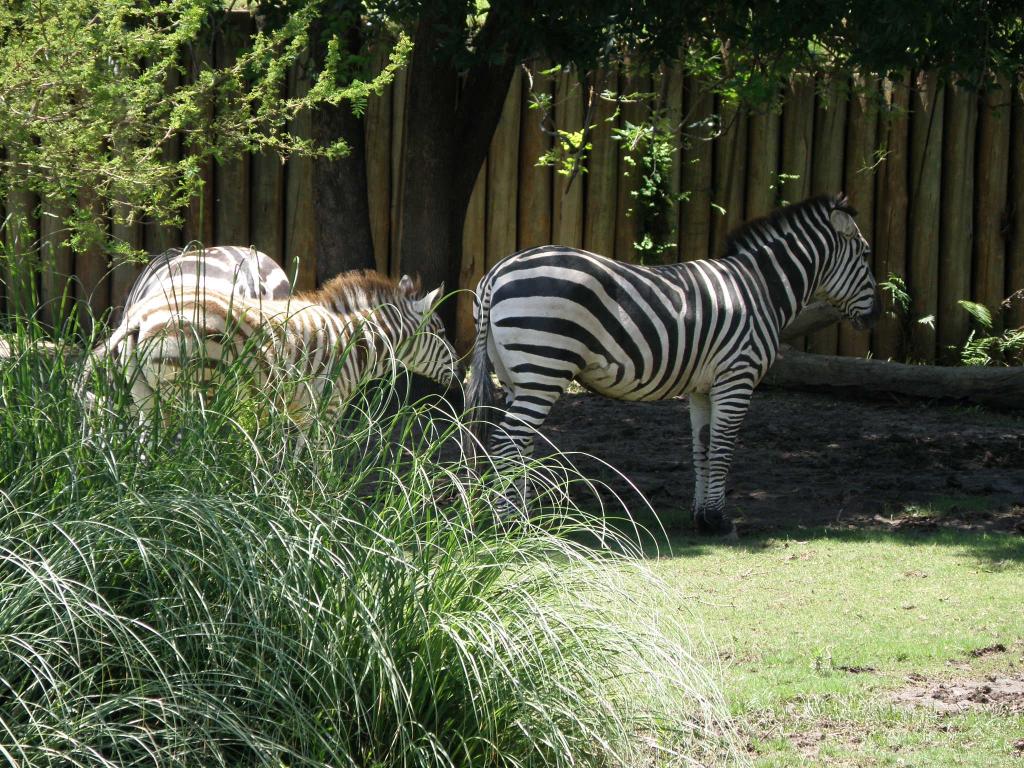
764,346,1024,411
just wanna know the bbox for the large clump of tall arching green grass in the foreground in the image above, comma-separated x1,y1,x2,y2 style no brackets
0,292,741,768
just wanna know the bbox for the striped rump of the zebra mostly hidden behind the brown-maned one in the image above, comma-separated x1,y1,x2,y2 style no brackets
122,246,292,316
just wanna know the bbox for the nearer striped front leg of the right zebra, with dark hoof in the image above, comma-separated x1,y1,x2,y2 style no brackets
698,376,754,534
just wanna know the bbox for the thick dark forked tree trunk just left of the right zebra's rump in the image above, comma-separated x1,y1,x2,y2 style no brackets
392,9,515,331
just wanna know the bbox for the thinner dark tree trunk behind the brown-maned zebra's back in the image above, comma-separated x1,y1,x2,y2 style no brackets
310,15,377,285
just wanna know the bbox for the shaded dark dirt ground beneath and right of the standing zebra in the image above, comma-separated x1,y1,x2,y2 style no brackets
542,388,1024,535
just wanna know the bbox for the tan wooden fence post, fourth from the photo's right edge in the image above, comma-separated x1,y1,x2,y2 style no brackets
907,72,946,362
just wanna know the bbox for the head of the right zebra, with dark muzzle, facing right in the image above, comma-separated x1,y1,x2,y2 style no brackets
817,195,882,331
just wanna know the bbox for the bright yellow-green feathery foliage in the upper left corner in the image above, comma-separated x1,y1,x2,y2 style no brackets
0,0,410,244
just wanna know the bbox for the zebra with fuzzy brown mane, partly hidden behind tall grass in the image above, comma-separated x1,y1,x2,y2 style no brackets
93,271,457,427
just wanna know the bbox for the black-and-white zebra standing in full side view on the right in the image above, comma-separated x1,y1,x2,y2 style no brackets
466,196,880,532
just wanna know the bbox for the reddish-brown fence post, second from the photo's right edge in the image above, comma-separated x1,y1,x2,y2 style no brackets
974,78,1011,331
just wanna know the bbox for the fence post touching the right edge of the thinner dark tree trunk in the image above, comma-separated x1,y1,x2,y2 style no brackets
365,40,393,274
